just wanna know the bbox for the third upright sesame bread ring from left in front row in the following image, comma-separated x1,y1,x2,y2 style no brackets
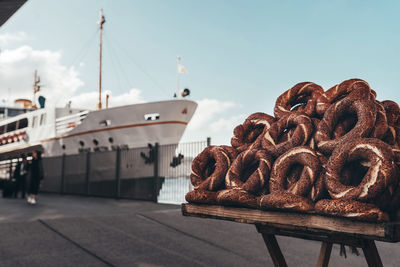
269,146,320,197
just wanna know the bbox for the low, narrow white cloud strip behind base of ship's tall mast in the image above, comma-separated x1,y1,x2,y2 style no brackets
70,88,144,109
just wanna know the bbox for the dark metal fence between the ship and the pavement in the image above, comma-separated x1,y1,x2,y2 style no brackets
0,140,209,204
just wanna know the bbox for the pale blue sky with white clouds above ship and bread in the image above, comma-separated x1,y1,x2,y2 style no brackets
0,0,400,147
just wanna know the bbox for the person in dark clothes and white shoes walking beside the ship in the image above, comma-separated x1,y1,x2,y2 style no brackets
27,151,44,205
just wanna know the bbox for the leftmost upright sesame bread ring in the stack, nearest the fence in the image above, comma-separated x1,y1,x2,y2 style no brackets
190,146,232,191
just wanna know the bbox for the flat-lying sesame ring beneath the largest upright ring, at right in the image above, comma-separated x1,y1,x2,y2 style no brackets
315,199,389,222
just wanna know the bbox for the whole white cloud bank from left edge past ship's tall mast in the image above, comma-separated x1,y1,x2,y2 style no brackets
0,44,144,109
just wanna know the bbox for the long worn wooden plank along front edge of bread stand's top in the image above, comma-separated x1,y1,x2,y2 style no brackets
182,204,400,242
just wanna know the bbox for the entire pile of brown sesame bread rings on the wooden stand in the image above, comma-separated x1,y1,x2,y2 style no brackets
186,79,400,222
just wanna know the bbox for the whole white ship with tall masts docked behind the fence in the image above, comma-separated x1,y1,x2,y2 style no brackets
0,9,197,160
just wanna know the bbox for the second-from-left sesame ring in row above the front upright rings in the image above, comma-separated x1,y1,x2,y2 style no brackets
261,113,314,158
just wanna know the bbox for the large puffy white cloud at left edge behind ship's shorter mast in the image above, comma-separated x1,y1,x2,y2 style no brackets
0,46,84,105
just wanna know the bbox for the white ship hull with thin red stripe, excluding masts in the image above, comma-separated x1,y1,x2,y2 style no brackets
0,99,197,157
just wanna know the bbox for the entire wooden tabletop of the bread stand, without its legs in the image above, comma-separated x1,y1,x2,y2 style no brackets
182,204,400,246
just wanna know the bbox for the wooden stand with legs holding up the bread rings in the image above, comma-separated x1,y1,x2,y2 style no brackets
182,204,400,266
